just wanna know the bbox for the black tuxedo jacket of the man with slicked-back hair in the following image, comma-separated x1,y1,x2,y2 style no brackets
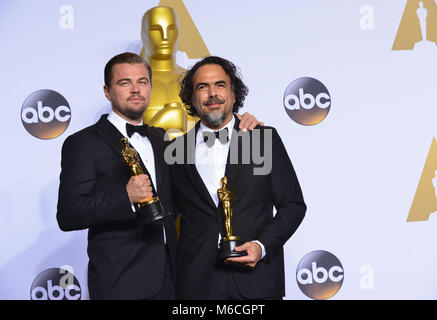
57,115,177,299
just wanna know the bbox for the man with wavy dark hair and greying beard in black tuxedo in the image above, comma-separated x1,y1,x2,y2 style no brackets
170,56,306,299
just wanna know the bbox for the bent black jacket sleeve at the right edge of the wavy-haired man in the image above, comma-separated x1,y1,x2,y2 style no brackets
257,128,306,260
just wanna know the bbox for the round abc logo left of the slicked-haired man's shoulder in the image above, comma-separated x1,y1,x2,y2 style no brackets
21,89,71,139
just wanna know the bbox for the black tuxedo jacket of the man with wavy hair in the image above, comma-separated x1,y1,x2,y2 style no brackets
170,119,306,299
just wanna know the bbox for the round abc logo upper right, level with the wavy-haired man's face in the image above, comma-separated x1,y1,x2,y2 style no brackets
284,77,331,126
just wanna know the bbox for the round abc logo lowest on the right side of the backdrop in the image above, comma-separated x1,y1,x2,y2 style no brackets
296,250,344,300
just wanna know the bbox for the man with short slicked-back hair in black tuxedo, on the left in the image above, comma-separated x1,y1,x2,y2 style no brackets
57,53,177,299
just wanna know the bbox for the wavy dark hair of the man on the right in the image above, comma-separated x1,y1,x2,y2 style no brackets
179,56,249,116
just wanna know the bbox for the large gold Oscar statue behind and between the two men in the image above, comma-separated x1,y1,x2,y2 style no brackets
141,6,198,138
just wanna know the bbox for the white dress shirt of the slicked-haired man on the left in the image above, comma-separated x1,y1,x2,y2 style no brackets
108,110,167,243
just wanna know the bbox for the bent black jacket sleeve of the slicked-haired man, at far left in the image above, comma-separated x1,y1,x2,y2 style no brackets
56,135,135,231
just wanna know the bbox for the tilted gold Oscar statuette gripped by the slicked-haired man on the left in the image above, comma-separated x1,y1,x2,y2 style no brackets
120,138,170,224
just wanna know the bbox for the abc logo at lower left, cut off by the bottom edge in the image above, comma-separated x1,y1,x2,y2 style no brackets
30,268,82,300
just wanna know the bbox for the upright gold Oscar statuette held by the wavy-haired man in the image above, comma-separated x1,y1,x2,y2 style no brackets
217,177,247,260
